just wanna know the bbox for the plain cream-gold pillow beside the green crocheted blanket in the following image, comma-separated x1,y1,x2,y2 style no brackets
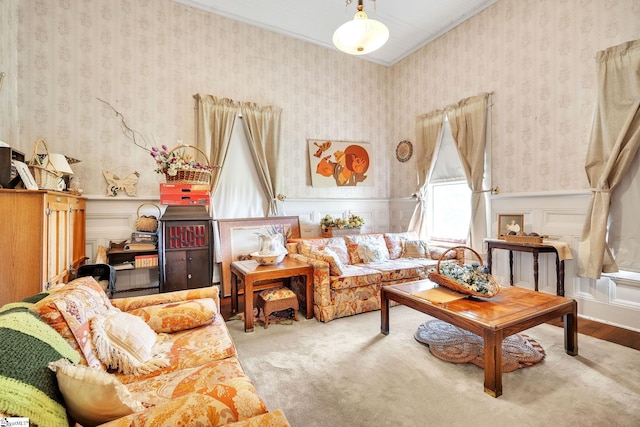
49,359,145,427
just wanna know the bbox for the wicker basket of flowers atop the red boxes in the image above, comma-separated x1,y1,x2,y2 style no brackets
151,144,219,185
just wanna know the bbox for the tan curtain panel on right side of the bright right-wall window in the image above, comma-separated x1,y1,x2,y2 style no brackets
446,93,489,253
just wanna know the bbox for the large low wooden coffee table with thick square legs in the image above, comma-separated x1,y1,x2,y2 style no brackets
380,280,578,397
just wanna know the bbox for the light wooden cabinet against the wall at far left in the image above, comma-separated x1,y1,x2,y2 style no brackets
0,190,86,305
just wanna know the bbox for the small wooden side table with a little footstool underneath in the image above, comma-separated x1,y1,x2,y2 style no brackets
231,256,313,332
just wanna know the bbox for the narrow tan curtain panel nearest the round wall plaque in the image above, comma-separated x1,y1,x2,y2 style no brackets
408,110,444,239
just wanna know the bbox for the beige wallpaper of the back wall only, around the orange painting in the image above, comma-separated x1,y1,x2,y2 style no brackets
10,0,389,198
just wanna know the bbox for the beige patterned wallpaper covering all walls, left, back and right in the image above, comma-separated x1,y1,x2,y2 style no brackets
5,0,640,198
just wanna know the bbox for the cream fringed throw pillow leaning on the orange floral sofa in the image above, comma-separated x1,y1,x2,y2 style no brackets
91,309,169,375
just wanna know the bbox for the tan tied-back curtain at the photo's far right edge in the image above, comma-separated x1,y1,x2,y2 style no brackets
578,40,640,279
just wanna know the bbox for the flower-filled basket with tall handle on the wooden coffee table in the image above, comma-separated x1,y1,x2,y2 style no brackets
428,246,500,298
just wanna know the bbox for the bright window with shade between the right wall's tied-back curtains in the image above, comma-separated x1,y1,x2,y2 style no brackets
427,118,471,244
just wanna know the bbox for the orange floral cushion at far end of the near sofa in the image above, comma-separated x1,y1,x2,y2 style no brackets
127,298,217,333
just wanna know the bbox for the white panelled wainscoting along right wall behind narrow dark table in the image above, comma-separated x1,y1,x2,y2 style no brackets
389,191,640,331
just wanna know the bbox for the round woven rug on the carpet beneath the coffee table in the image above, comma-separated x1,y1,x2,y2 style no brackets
415,320,545,372
